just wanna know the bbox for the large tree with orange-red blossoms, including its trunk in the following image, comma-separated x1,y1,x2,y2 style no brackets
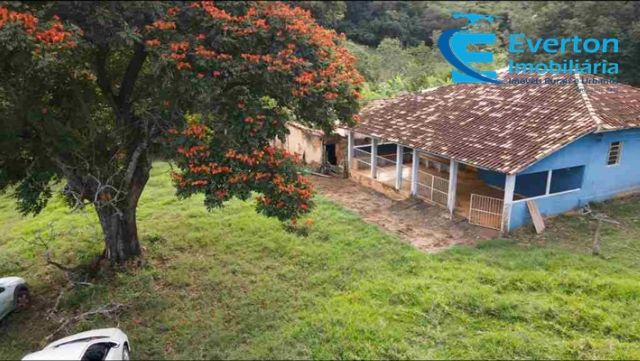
0,2,362,263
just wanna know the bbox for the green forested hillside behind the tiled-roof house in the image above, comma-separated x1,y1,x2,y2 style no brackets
295,1,640,98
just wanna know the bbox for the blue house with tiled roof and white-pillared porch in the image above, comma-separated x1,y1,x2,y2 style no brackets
348,74,640,231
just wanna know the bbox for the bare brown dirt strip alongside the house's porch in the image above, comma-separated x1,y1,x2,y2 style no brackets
312,176,498,252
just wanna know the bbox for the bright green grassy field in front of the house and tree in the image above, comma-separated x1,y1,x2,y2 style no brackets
0,164,640,359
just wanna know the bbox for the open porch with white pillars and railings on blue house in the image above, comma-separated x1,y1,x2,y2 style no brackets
348,132,520,231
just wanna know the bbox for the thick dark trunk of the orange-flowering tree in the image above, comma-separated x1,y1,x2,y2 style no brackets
96,159,151,264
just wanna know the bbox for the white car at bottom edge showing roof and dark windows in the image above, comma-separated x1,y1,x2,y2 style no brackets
22,328,130,361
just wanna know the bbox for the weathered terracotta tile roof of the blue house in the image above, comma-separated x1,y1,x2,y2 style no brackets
354,75,640,174
